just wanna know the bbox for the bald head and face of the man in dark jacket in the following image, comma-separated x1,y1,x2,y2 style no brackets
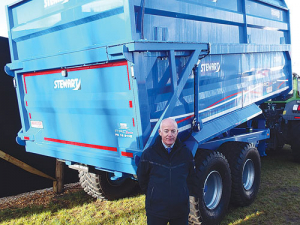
158,119,178,147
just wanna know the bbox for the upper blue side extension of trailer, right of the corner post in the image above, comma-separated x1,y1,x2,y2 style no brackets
135,0,290,44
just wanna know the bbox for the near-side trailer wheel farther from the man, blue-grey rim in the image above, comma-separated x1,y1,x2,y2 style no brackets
219,142,261,206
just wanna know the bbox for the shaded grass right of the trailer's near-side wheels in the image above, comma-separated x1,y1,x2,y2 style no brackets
222,146,300,225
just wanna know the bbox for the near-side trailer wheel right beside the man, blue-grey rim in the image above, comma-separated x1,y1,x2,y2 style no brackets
189,149,231,225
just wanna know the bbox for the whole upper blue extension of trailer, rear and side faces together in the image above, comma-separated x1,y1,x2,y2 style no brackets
7,0,290,61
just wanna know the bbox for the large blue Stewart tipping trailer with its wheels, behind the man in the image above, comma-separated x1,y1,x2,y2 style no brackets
5,0,292,224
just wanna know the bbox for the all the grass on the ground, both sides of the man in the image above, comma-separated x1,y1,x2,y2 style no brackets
0,146,300,225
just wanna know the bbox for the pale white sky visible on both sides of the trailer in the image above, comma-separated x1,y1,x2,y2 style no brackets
0,0,300,72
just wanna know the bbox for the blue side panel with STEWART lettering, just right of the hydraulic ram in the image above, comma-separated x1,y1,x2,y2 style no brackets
199,54,243,122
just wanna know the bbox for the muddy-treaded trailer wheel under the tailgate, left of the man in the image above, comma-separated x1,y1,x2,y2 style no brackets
79,171,137,200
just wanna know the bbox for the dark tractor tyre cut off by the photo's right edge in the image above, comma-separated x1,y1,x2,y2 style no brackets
289,121,300,162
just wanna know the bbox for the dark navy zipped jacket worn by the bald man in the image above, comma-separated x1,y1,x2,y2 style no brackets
137,136,195,219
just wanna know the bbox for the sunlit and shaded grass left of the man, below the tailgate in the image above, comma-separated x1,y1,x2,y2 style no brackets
0,191,146,225
